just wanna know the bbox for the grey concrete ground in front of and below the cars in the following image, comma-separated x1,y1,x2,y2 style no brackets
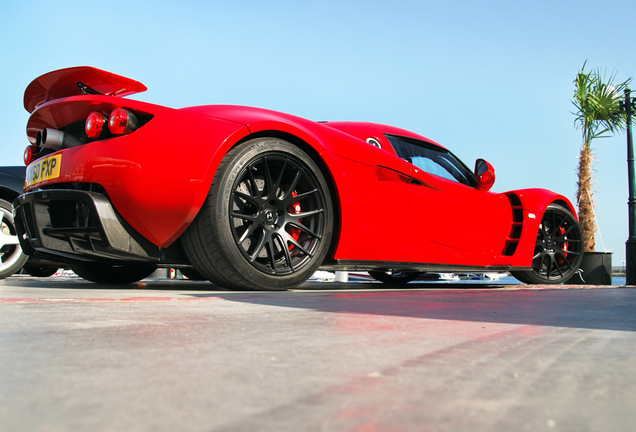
0,276,636,432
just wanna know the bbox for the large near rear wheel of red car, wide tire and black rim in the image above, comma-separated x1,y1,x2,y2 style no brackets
181,138,334,290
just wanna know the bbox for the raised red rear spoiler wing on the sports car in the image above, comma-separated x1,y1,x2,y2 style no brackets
24,66,148,113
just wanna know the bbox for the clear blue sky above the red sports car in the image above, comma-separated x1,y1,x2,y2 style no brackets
0,0,636,265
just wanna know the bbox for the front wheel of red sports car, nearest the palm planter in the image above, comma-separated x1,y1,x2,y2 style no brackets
510,204,583,284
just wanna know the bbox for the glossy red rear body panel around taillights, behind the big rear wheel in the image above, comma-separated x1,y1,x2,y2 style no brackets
26,95,248,247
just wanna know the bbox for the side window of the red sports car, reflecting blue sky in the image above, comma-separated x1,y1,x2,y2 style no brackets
387,135,475,186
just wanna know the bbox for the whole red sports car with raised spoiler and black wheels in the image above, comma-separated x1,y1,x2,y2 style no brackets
15,67,582,290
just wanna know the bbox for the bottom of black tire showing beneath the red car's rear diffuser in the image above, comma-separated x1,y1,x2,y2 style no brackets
70,263,157,285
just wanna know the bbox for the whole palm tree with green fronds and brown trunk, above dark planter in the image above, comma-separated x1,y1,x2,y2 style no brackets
572,62,631,252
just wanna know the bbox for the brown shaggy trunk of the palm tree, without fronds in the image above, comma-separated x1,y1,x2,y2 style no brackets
577,142,596,252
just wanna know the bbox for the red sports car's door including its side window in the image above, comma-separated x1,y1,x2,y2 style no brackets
388,136,512,266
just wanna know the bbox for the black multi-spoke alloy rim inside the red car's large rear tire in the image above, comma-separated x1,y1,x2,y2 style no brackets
229,152,325,275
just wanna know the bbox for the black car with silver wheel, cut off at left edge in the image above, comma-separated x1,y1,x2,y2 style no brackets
0,166,61,279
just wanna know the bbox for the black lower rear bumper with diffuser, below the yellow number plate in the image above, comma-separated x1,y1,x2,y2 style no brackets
14,189,183,264
